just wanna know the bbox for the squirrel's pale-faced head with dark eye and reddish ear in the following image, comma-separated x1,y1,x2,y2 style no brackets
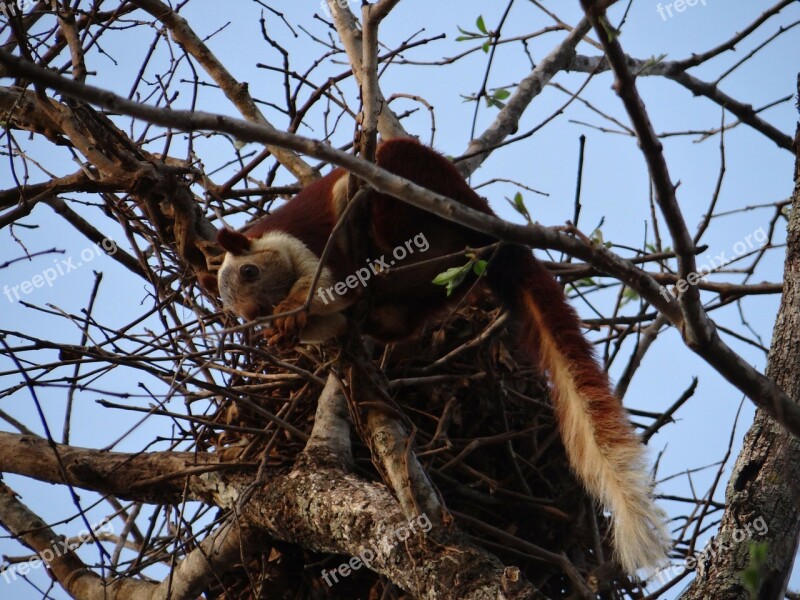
217,229,297,321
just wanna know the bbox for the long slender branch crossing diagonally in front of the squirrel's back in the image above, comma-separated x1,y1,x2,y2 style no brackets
0,51,800,437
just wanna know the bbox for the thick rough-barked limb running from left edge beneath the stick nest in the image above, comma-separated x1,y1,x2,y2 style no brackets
0,433,545,600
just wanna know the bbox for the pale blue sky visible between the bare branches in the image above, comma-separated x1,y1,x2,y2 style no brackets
0,0,800,599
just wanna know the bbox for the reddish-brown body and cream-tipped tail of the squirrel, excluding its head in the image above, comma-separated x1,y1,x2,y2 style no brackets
214,139,666,572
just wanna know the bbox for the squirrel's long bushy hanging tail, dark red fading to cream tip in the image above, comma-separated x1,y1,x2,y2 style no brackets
487,245,668,574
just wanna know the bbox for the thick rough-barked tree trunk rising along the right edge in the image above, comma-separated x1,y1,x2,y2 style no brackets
683,78,800,600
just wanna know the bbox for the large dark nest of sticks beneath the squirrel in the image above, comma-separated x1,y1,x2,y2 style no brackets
199,290,635,600
